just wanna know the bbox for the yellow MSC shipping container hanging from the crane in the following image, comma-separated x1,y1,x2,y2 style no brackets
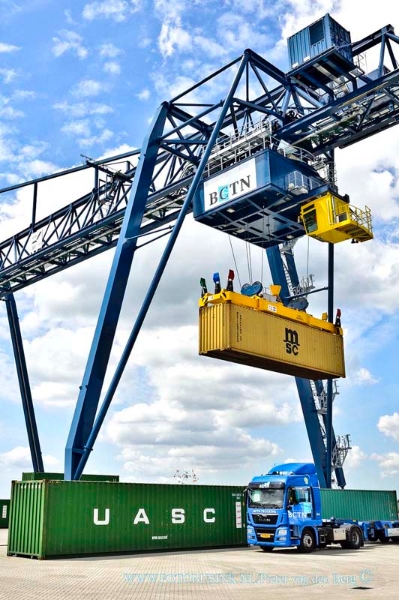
199,302,345,379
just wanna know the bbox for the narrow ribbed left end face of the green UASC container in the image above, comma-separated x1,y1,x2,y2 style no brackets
8,481,46,558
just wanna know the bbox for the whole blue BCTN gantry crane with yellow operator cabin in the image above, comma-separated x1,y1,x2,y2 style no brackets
0,15,399,487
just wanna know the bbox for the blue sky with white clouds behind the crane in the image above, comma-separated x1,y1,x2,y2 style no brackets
0,0,399,497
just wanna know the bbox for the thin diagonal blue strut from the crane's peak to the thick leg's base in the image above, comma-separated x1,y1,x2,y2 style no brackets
65,52,249,479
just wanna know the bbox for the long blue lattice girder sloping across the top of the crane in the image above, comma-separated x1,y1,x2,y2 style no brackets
0,33,399,297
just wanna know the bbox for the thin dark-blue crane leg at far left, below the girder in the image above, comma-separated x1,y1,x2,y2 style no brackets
5,293,44,473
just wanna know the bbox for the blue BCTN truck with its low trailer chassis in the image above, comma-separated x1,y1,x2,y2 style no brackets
246,463,399,553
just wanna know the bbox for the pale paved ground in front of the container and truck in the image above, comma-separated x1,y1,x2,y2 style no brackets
0,529,399,600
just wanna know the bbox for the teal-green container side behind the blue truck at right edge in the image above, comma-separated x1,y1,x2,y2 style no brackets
320,489,398,521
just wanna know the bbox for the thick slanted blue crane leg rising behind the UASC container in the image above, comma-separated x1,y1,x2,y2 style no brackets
65,103,168,480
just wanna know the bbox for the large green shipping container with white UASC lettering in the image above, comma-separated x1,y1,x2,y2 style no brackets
8,481,247,558
